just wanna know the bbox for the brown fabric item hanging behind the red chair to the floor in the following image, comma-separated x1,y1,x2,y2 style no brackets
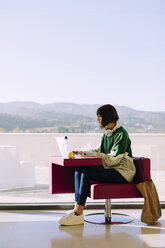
136,180,162,224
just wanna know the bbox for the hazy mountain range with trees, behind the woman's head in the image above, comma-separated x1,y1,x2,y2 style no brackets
0,102,165,133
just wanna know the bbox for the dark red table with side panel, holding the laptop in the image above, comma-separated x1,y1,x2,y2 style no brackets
49,157,102,194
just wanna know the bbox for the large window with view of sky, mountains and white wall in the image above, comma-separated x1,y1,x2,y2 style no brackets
0,0,165,207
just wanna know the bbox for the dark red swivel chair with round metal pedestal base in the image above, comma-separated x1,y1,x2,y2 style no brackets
85,158,151,224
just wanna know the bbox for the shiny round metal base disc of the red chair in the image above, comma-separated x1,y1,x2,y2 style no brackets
84,213,134,225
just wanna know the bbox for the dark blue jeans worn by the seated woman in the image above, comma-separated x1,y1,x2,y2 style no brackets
74,166,128,206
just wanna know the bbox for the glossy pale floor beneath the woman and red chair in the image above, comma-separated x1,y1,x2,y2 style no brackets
0,209,165,248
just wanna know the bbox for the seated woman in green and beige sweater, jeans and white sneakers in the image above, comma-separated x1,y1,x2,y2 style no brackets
59,104,136,225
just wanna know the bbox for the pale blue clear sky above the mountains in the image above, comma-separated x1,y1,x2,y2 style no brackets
0,0,165,111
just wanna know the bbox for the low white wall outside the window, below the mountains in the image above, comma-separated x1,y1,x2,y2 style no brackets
0,133,165,170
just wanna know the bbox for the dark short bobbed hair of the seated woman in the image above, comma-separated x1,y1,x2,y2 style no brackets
96,104,119,127
